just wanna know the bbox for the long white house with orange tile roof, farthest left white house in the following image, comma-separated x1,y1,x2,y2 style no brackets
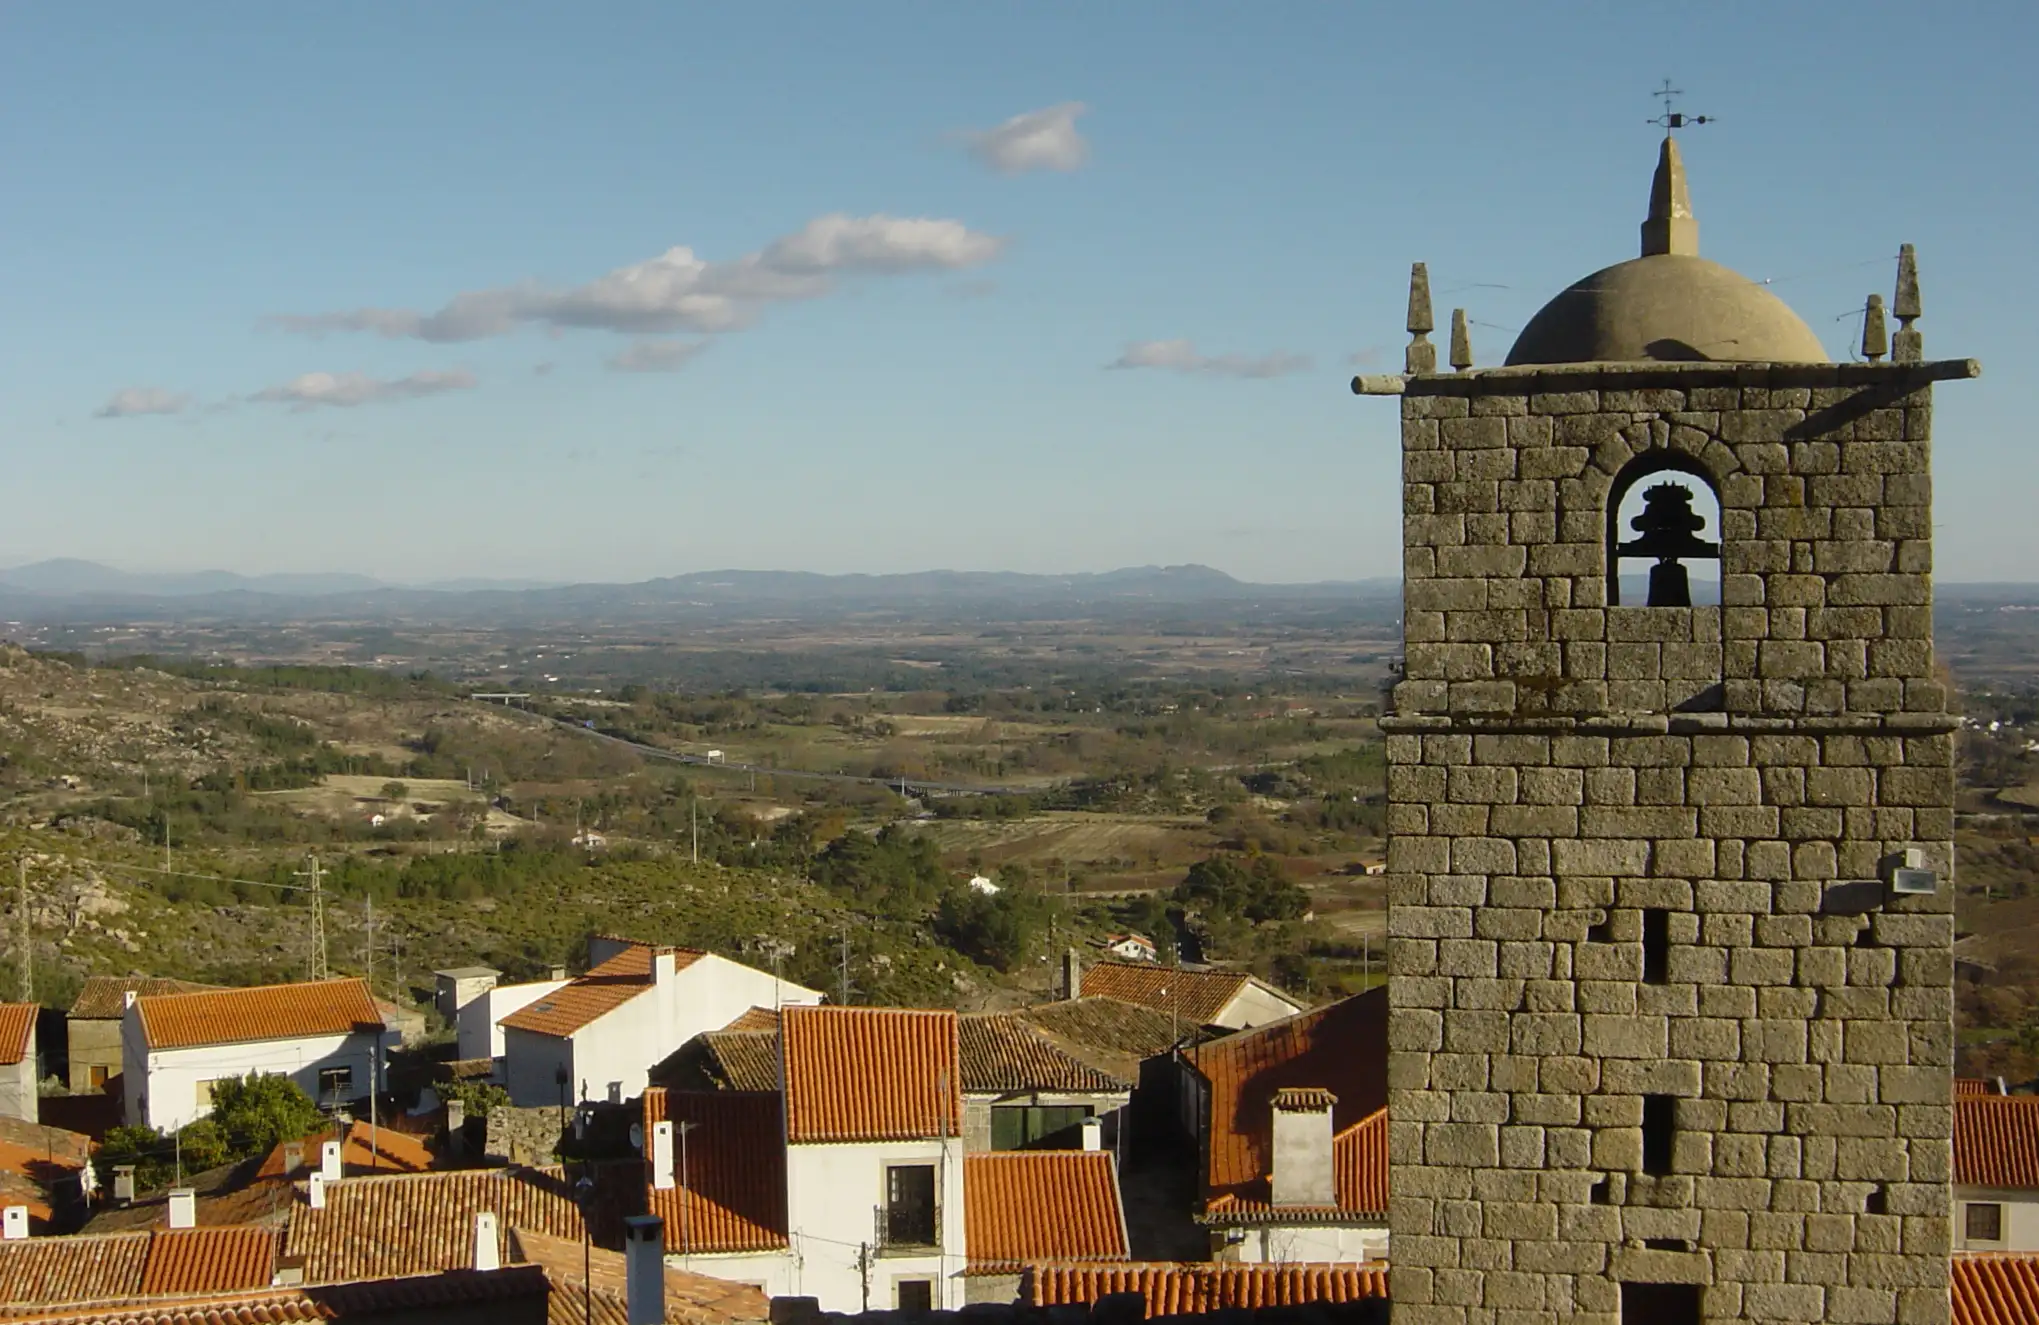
120,978,396,1131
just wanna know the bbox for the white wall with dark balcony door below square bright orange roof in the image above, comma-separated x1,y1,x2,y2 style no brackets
785,1137,969,1311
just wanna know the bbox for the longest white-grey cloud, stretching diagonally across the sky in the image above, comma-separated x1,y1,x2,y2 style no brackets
267,212,1005,342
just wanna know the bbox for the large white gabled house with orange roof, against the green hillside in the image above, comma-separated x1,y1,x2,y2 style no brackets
500,936,822,1107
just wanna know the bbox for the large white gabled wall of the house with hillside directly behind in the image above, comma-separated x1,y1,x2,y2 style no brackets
504,954,822,1107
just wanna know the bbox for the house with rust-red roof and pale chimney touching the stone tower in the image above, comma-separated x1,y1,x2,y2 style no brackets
1179,989,1389,1262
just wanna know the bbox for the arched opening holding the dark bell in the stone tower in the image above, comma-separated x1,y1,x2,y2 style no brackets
1607,451,1721,607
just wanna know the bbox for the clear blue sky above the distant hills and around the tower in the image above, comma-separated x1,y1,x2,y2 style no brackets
0,0,2039,581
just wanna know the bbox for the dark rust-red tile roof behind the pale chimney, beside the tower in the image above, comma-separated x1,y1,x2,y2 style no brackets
1187,989,1389,1201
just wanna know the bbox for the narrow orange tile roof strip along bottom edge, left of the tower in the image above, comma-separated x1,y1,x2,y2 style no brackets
1020,1262,1389,1319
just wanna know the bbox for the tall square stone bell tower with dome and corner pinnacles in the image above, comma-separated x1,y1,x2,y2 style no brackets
1354,139,1978,1325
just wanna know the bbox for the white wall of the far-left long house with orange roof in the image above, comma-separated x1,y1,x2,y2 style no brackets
120,1007,398,1131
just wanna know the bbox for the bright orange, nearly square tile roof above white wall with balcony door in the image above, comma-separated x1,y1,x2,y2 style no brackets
781,1007,962,1144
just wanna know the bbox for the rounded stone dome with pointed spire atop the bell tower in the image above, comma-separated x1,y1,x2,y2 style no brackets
1509,137,1827,365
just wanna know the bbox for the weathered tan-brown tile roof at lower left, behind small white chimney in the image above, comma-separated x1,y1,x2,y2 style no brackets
283,1168,581,1282
